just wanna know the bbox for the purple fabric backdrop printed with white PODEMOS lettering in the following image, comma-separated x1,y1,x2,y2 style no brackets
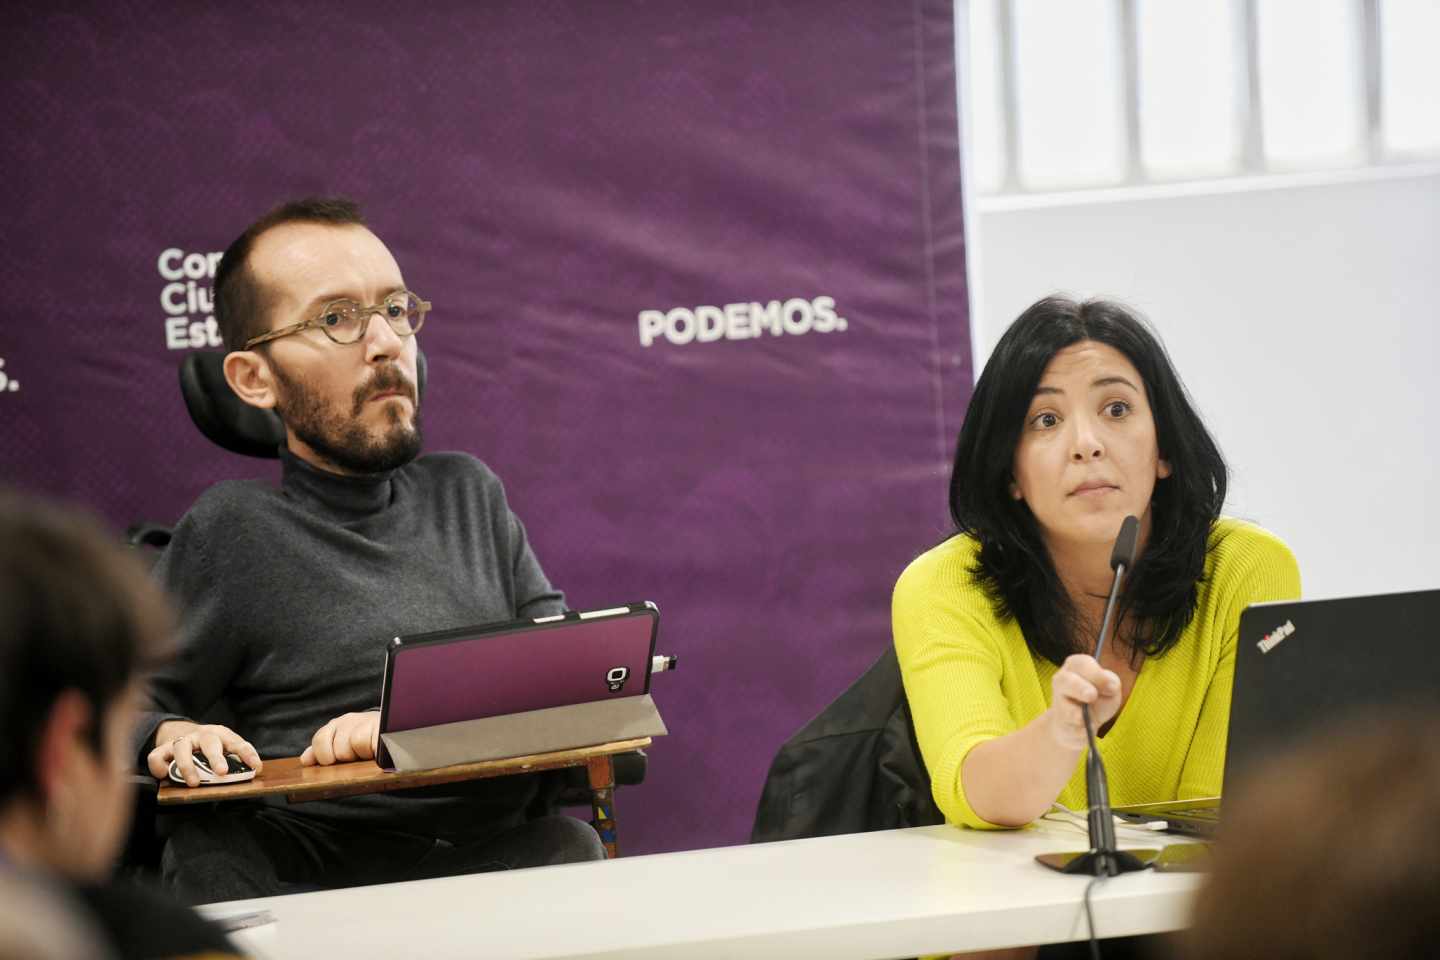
0,0,971,852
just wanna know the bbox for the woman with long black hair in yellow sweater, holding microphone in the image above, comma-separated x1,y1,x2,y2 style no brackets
893,296,1300,828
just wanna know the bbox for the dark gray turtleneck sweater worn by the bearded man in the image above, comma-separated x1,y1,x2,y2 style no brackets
137,449,563,839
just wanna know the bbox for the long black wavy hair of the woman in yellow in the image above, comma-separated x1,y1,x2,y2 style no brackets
950,296,1228,665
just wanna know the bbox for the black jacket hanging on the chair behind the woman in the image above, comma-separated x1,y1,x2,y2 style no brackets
750,646,945,843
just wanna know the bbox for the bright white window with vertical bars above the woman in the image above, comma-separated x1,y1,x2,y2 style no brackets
956,0,1440,194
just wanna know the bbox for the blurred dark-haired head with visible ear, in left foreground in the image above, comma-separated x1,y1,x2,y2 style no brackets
0,489,173,881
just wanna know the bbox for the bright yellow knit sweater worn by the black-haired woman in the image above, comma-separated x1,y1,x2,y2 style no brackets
891,520,1300,829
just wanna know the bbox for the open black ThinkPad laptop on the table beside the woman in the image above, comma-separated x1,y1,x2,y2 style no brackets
1115,590,1440,836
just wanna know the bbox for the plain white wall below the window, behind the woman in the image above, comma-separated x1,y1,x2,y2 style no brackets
968,166,1440,597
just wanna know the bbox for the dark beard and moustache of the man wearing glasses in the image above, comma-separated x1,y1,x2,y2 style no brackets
271,363,420,474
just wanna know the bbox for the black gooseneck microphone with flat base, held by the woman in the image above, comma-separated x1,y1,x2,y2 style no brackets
1035,515,1159,877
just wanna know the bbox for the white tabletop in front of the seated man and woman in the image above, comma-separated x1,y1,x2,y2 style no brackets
204,822,1198,960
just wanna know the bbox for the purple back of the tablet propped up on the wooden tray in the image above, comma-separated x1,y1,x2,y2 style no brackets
376,602,660,767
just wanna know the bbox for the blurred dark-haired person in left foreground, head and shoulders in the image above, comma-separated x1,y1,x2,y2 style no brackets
0,489,235,959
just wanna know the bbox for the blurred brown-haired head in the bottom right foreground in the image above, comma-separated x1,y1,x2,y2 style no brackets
1184,711,1440,960
